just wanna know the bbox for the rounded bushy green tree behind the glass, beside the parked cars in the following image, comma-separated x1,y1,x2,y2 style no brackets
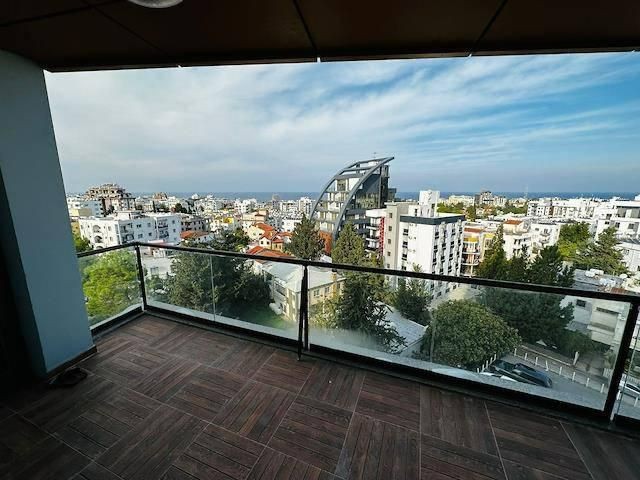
419,300,521,369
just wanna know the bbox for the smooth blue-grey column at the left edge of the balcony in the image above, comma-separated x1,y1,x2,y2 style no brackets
0,51,93,376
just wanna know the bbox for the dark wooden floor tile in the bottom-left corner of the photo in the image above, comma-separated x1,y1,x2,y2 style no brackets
4,436,89,480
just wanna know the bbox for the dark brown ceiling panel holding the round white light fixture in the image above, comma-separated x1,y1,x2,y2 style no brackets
99,0,314,64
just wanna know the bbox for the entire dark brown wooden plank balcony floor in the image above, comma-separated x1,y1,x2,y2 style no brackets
0,315,640,480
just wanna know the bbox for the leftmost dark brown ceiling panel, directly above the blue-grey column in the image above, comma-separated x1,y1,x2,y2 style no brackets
0,10,164,70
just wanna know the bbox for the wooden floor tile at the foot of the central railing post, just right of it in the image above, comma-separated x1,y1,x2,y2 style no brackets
300,362,364,411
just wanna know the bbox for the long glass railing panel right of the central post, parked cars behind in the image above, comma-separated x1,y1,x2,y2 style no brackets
309,268,629,410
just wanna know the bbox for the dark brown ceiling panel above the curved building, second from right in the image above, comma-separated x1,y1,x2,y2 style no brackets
299,0,501,57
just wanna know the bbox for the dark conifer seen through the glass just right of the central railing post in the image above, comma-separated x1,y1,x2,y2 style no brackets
328,273,405,352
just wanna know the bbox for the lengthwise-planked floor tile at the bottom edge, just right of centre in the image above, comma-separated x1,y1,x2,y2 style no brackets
335,413,420,480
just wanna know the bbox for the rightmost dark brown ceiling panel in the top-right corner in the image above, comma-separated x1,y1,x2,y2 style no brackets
478,0,640,53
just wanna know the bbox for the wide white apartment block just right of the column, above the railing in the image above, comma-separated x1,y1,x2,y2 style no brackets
79,211,180,249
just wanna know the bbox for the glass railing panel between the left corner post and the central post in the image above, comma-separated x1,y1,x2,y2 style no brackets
142,248,303,338
